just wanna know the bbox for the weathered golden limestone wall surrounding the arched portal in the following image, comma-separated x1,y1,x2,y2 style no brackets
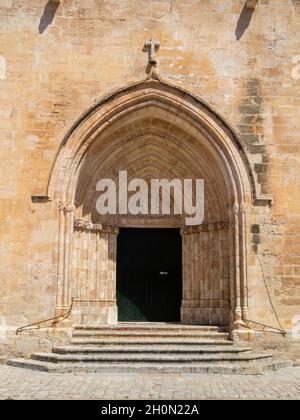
0,0,300,351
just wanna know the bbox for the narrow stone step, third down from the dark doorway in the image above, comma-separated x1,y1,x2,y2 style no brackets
72,337,233,347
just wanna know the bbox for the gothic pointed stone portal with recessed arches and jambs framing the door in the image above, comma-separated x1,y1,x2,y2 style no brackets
48,80,257,325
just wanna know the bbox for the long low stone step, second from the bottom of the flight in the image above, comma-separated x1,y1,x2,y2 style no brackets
31,353,272,364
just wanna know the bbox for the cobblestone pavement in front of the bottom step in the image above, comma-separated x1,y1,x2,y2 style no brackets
0,365,300,400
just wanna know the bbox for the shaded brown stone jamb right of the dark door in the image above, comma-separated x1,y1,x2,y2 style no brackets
181,222,230,325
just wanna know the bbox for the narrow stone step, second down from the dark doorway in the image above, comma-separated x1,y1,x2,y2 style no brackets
72,330,229,340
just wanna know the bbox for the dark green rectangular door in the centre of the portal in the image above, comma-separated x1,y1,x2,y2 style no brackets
117,229,182,322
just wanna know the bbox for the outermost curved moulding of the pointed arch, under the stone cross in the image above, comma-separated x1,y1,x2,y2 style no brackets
47,80,268,205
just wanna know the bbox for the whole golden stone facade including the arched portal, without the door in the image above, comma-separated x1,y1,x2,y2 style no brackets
0,0,300,354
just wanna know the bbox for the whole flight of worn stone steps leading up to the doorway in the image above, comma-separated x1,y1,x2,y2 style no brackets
8,323,290,374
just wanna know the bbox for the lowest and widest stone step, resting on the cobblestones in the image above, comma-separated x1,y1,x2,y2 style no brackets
7,359,291,375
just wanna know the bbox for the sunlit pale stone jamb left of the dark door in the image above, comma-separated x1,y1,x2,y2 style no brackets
72,220,119,324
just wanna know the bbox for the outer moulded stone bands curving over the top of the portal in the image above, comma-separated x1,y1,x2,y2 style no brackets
48,76,270,205
